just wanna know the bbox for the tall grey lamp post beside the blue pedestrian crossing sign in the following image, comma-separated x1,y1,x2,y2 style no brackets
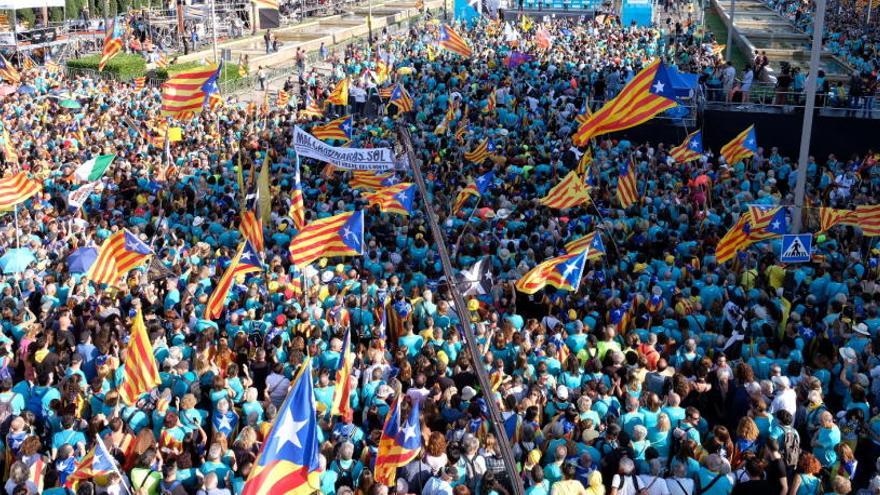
791,0,825,234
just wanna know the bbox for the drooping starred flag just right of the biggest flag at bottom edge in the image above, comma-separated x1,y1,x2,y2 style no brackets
375,396,422,486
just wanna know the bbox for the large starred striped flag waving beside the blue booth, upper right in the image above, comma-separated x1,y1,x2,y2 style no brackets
572,61,676,146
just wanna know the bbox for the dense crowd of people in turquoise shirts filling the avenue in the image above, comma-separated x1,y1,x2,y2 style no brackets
0,6,880,495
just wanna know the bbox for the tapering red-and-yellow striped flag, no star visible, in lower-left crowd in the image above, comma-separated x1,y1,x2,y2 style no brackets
119,309,162,406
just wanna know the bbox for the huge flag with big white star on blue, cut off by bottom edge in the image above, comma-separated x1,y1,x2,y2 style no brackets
241,358,321,495
